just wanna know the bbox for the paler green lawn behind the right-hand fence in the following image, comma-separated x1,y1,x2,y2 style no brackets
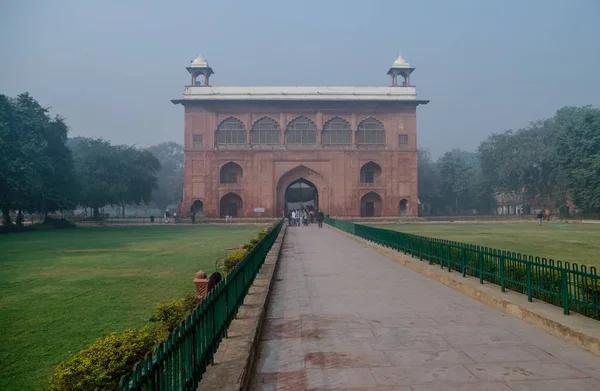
370,222,600,269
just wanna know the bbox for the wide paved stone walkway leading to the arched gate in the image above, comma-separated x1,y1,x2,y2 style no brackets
251,226,600,391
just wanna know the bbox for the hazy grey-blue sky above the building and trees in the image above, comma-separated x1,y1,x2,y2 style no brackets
0,0,600,156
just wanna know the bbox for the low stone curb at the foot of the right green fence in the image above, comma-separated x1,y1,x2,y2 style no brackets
327,226,600,356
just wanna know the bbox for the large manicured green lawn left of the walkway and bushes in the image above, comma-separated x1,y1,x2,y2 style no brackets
0,225,264,390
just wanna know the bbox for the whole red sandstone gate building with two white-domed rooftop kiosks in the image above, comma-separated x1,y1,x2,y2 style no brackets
172,56,428,217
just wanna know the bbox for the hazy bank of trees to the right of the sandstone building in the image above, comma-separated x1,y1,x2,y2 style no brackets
418,106,600,214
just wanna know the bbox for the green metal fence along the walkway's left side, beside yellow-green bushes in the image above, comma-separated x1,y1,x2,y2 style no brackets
119,220,283,391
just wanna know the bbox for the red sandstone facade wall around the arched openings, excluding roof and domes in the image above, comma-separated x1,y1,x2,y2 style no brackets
184,102,418,217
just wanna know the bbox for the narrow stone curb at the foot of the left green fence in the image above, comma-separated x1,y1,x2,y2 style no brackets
198,225,287,391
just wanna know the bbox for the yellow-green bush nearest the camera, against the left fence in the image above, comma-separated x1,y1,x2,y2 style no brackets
50,327,156,391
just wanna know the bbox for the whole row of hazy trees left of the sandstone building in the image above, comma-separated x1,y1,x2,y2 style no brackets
0,93,183,226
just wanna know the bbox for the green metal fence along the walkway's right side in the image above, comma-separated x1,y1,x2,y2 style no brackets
325,218,600,319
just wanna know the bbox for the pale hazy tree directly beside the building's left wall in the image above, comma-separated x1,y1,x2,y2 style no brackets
148,142,183,210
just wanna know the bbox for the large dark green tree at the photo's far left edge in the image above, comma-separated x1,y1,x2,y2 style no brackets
0,93,73,225
